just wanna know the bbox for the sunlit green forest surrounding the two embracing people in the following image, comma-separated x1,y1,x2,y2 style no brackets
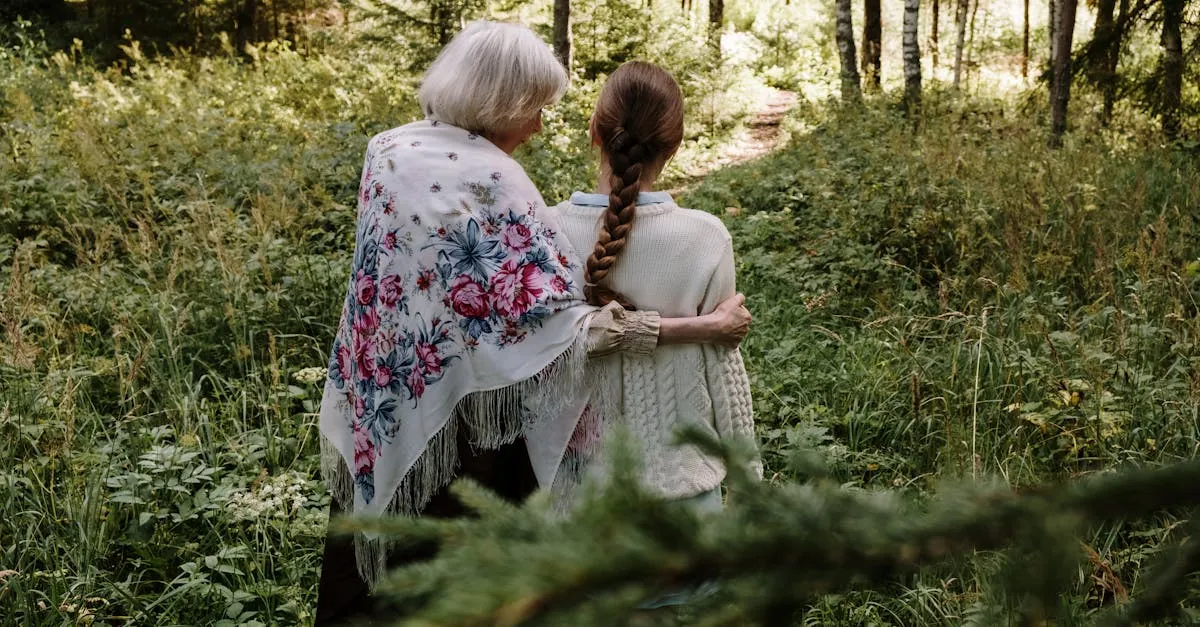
0,0,1200,626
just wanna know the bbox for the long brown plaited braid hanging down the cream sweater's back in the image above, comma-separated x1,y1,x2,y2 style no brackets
583,126,646,310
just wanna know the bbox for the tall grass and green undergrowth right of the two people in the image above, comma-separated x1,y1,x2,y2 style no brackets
683,91,1200,625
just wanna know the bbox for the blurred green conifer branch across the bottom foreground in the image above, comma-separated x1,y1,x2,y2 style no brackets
362,430,1200,625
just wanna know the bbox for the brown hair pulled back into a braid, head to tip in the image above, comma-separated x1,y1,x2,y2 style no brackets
583,61,683,309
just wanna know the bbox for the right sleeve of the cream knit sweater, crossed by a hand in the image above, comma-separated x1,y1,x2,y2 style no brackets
700,233,762,479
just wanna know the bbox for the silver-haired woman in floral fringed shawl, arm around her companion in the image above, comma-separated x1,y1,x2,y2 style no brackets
317,22,750,625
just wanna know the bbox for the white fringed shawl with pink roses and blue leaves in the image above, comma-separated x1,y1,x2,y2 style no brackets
320,121,594,581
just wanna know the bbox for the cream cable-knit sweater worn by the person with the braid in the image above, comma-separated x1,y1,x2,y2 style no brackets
552,192,762,498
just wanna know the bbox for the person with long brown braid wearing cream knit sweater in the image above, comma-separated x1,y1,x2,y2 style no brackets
556,61,762,509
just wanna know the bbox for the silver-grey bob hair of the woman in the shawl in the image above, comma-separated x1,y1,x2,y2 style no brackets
419,20,566,132
